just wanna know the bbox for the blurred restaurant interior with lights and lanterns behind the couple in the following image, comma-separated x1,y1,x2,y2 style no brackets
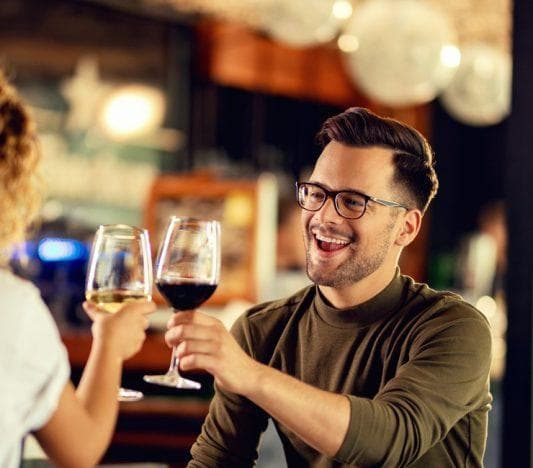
0,0,531,467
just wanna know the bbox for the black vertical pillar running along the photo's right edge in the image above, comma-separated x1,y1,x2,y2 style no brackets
502,1,533,467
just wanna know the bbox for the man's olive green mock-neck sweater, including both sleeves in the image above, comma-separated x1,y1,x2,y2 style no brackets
189,273,491,468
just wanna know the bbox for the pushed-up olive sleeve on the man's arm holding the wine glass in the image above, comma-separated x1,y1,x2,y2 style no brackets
336,304,491,467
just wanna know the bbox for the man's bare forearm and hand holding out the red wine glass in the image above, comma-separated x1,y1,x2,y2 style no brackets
165,311,350,456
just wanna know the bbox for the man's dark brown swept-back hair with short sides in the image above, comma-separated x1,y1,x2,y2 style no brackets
317,107,439,212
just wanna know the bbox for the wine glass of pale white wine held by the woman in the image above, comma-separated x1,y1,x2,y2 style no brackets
85,224,152,401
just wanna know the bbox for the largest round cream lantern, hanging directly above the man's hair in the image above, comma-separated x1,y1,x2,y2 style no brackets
343,0,461,106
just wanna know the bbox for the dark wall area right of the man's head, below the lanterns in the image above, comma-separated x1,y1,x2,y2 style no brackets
430,101,507,252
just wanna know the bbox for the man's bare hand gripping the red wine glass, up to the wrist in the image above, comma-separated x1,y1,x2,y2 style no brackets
165,311,261,396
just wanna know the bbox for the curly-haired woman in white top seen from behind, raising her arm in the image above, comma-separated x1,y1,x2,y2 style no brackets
0,72,155,467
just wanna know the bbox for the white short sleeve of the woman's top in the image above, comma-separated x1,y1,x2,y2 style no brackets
0,280,70,453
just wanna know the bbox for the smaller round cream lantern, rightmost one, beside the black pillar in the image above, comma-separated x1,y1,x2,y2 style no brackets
441,43,512,126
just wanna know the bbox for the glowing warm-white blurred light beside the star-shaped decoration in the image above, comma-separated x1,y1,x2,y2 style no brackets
100,85,165,140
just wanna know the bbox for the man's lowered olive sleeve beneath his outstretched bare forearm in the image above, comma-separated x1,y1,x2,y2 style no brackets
187,317,268,468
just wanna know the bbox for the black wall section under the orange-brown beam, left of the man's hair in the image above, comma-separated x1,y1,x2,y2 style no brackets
190,78,343,179
